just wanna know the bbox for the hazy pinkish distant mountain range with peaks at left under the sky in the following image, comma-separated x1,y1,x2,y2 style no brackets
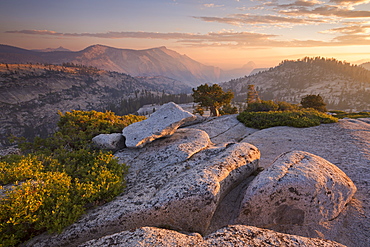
0,45,255,87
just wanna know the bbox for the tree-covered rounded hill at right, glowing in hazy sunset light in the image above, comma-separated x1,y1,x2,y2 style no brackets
221,57,370,111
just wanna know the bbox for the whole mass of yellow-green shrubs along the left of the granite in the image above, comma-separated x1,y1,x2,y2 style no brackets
0,111,144,246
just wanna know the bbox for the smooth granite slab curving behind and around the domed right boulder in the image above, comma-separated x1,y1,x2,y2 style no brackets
243,119,370,247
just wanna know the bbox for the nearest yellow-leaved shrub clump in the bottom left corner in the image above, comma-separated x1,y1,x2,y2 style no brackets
0,169,76,246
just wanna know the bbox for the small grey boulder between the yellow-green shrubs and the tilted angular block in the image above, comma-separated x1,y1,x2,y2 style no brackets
92,133,126,151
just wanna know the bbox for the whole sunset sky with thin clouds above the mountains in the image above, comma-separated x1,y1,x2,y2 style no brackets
0,0,370,69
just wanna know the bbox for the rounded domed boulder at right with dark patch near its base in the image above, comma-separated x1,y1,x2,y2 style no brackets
236,151,356,230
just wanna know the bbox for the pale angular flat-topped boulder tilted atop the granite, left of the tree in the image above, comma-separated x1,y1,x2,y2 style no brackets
122,102,196,148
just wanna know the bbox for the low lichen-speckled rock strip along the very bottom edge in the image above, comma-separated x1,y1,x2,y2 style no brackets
79,225,344,247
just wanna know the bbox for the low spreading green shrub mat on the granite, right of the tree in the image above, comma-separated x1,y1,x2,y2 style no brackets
237,110,338,129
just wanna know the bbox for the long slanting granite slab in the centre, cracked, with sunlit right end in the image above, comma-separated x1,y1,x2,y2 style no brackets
28,129,260,246
